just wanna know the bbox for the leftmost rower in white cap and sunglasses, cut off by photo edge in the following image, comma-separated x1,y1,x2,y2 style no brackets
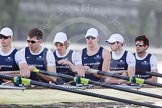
0,27,30,83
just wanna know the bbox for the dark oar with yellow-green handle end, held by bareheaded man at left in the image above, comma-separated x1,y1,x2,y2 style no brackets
33,69,162,99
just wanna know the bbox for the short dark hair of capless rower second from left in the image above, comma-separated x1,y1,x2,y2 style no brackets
28,28,43,40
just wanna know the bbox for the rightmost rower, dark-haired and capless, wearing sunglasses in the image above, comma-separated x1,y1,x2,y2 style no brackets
134,35,158,82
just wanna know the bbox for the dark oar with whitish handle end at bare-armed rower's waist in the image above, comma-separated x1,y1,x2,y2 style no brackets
88,69,162,87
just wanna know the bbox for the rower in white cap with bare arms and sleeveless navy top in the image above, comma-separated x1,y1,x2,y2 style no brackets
81,28,110,81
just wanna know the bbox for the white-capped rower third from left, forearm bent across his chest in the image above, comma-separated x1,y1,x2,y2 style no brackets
53,32,84,85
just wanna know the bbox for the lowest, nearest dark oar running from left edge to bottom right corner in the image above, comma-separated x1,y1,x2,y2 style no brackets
0,74,162,108
